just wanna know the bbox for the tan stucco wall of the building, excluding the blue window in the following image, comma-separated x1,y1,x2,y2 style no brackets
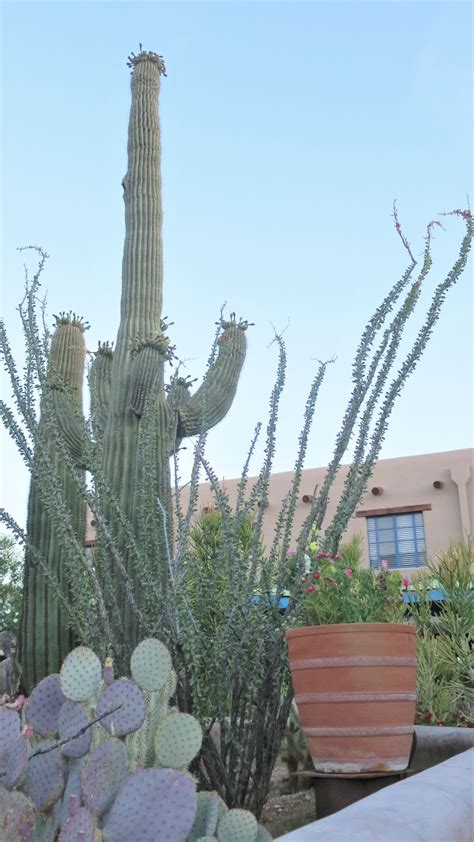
183,442,474,575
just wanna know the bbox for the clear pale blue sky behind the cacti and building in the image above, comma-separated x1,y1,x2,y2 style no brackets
1,0,473,521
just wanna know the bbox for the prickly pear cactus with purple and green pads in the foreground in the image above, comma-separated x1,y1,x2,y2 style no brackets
0,640,270,842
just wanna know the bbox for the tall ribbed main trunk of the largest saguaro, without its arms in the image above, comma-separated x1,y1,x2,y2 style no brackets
103,53,170,642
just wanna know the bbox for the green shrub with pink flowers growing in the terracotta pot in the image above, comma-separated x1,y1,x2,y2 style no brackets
302,542,407,625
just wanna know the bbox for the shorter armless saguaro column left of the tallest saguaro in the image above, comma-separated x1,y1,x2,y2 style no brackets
20,314,85,689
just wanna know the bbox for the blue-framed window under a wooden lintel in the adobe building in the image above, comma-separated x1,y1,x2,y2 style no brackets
367,512,426,570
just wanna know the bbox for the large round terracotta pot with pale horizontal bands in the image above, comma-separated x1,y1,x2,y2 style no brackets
287,623,416,774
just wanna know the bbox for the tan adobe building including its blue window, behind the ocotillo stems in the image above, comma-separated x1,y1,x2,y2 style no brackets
183,449,474,576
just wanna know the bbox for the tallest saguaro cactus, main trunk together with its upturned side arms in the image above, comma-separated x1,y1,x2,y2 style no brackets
92,51,247,643
